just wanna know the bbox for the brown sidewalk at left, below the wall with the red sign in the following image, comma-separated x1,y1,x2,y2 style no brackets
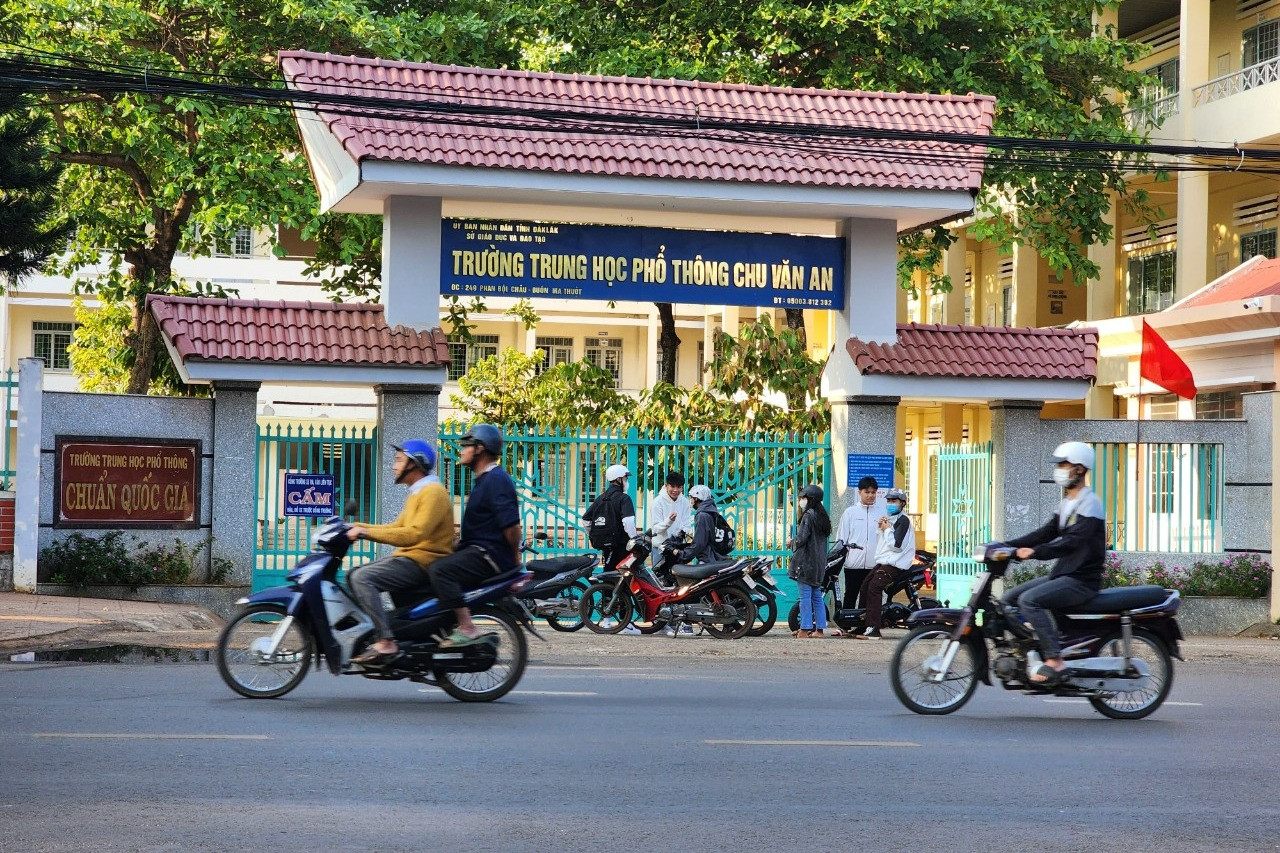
0,592,221,652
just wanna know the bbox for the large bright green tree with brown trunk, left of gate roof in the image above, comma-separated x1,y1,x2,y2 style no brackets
0,0,527,393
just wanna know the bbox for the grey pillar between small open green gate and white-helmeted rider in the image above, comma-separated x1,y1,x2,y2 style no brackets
991,400,1053,540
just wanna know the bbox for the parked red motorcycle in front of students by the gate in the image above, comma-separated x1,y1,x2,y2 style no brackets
580,533,755,639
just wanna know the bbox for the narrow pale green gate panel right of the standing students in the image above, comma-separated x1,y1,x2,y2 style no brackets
937,442,991,607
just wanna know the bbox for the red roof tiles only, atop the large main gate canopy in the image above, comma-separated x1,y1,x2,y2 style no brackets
280,51,995,191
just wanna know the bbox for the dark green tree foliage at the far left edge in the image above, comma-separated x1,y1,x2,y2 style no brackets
0,91,73,281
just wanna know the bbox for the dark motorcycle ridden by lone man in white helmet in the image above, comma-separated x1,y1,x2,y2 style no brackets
890,543,1183,720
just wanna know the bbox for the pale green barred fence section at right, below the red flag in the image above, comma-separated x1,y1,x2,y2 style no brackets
1091,443,1222,553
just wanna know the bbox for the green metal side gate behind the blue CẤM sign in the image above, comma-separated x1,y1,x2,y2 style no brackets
253,424,380,590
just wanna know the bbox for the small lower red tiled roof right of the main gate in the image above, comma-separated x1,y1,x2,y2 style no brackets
845,323,1098,380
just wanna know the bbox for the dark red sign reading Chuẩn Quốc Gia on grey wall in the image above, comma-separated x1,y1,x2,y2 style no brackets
56,438,200,526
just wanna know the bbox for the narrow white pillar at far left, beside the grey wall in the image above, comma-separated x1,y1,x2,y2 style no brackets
11,359,42,593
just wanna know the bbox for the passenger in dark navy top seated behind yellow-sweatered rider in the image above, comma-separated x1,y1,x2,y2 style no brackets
429,424,520,648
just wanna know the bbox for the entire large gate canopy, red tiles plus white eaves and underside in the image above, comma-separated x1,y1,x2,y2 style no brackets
279,51,995,234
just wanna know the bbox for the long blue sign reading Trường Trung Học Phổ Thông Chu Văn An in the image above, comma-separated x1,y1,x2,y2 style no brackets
440,219,845,310
